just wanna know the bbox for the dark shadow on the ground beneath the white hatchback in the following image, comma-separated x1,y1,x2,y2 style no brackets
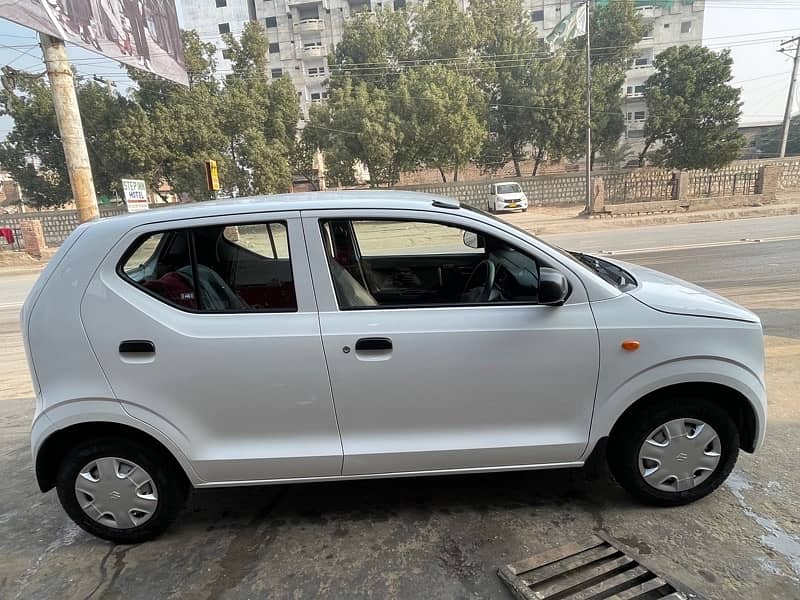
180,468,634,527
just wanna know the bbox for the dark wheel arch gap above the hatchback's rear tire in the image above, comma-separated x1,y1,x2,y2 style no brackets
35,421,191,492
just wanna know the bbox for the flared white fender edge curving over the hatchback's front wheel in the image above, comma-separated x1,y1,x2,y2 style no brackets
586,357,767,456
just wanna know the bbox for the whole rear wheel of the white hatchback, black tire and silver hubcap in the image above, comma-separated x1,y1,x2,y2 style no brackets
56,438,188,544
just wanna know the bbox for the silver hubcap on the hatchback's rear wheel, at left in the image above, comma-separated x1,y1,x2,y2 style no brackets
75,456,158,529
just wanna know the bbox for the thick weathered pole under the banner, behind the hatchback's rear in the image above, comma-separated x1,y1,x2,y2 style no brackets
39,33,100,223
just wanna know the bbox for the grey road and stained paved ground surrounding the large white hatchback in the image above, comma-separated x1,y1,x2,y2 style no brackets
0,217,800,600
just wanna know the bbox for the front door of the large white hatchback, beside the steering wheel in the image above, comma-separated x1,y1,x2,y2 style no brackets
303,211,598,475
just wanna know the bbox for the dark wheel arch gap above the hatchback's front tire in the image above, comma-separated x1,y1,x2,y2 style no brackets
609,382,758,452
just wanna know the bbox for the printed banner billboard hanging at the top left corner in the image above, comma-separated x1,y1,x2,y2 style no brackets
0,0,189,85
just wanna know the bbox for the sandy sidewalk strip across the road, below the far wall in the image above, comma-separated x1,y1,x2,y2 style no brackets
500,192,800,235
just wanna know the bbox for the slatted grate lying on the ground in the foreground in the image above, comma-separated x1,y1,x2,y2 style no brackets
498,535,702,600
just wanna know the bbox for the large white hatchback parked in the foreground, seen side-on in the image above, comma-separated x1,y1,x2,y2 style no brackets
22,191,766,543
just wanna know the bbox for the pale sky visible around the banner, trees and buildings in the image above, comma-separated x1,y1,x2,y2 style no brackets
0,0,800,139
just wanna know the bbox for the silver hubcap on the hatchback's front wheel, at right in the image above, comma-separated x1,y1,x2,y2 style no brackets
639,419,722,492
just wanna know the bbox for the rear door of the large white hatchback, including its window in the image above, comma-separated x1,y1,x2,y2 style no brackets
81,212,342,483
